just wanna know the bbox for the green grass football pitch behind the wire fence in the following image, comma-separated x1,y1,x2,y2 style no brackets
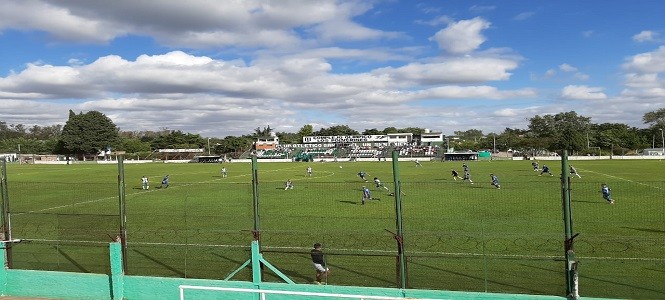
1,160,665,299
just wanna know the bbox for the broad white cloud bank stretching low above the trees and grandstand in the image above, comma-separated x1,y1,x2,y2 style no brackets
0,49,537,136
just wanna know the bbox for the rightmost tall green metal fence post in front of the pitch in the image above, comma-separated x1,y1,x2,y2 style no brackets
561,150,580,299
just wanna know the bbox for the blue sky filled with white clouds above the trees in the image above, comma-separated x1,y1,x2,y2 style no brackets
0,0,665,138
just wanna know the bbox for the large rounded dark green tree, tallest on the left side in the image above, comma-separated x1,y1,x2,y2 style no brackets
60,110,119,157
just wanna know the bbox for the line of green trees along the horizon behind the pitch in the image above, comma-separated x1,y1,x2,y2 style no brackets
0,108,665,158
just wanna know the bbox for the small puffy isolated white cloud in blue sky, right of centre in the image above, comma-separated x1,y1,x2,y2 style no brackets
430,17,491,54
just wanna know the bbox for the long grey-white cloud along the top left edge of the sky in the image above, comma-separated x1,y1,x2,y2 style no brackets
0,0,399,48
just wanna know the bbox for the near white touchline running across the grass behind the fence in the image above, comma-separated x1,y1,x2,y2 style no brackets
23,239,665,262
